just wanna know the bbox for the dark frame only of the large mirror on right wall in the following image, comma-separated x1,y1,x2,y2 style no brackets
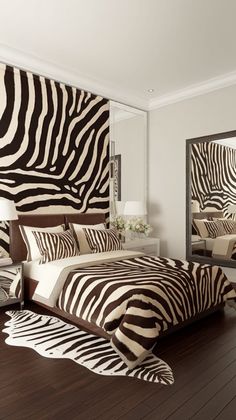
186,130,236,268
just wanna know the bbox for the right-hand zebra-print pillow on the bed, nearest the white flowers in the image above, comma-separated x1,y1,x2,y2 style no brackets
83,229,123,253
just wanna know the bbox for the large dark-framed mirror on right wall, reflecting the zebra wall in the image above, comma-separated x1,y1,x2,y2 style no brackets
186,131,236,267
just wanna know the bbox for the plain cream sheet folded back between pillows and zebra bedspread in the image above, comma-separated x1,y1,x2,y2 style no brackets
24,250,144,307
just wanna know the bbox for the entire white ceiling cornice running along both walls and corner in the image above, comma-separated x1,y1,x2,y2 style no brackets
0,44,236,111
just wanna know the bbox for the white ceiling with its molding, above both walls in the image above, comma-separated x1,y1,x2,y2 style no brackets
0,0,236,109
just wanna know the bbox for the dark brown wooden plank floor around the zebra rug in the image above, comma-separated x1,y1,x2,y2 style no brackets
0,306,236,420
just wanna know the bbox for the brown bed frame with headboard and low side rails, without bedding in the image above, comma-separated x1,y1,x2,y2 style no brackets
10,213,224,339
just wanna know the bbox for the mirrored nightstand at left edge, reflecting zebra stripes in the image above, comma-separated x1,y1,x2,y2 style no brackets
0,263,24,309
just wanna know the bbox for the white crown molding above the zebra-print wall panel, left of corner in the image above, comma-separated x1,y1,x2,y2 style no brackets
0,44,148,111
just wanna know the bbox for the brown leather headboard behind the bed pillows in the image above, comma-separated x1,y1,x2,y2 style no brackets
10,213,105,261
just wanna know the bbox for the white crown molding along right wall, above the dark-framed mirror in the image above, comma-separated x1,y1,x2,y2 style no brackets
148,71,236,111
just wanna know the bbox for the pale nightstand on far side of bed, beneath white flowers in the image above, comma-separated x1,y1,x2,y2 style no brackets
122,238,160,257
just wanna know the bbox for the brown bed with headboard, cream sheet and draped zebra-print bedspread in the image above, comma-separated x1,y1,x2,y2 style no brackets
10,213,236,368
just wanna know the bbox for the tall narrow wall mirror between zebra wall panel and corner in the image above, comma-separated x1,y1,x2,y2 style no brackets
110,101,147,214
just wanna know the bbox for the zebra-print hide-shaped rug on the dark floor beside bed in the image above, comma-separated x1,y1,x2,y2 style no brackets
3,310,174,385
